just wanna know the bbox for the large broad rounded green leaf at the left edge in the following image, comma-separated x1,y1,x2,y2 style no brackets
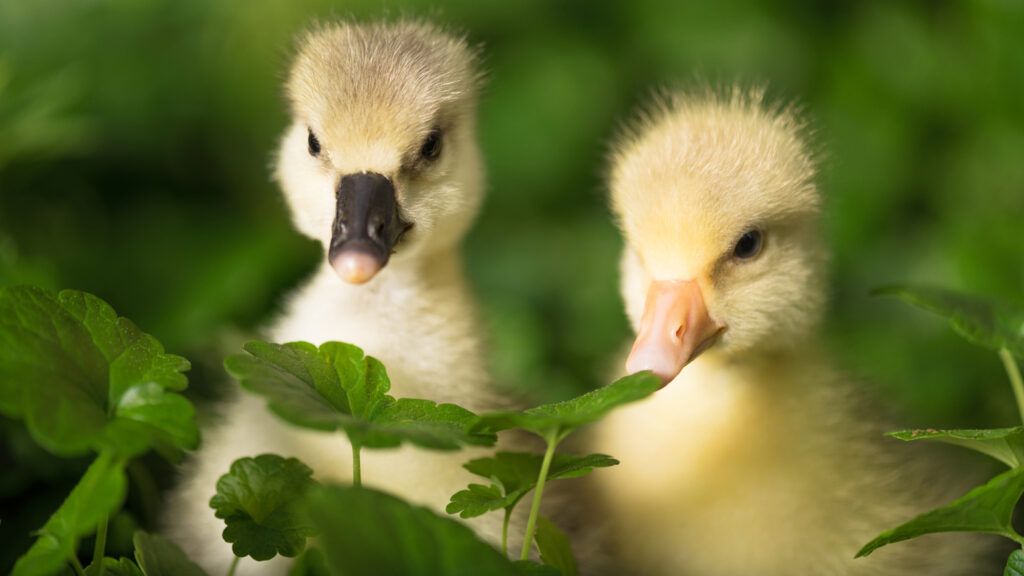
0,286,199,458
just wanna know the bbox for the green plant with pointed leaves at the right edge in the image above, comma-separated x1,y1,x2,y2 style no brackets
857,287,1024,576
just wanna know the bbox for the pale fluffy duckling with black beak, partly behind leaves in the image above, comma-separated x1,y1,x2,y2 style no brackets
161,22,509,574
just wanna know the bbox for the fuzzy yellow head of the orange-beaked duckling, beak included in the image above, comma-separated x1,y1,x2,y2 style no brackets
609,92,824,382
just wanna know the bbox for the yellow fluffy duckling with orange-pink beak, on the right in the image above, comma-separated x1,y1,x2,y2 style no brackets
592,90,985,576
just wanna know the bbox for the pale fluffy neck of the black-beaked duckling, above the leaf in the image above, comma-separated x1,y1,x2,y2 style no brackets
271,251,489,409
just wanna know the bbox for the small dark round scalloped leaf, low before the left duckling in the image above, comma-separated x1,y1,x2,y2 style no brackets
210,454,316,561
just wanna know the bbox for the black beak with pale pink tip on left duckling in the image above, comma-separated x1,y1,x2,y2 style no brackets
328,172,412,284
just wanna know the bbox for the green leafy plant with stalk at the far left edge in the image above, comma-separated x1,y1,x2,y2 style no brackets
0,287,199,576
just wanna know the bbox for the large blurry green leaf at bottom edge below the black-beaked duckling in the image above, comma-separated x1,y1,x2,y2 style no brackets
306,486,518,576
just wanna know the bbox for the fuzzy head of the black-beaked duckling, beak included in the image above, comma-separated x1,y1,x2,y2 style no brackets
276,23,483,284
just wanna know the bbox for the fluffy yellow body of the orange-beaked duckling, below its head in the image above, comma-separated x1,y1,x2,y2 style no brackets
594,351,988,576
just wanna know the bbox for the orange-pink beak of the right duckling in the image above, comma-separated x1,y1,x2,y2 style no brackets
626,280,724,384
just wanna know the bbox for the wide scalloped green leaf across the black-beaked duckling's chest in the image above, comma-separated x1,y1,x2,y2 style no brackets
224,341,496,450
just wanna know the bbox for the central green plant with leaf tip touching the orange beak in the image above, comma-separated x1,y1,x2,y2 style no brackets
224,341,660,574
